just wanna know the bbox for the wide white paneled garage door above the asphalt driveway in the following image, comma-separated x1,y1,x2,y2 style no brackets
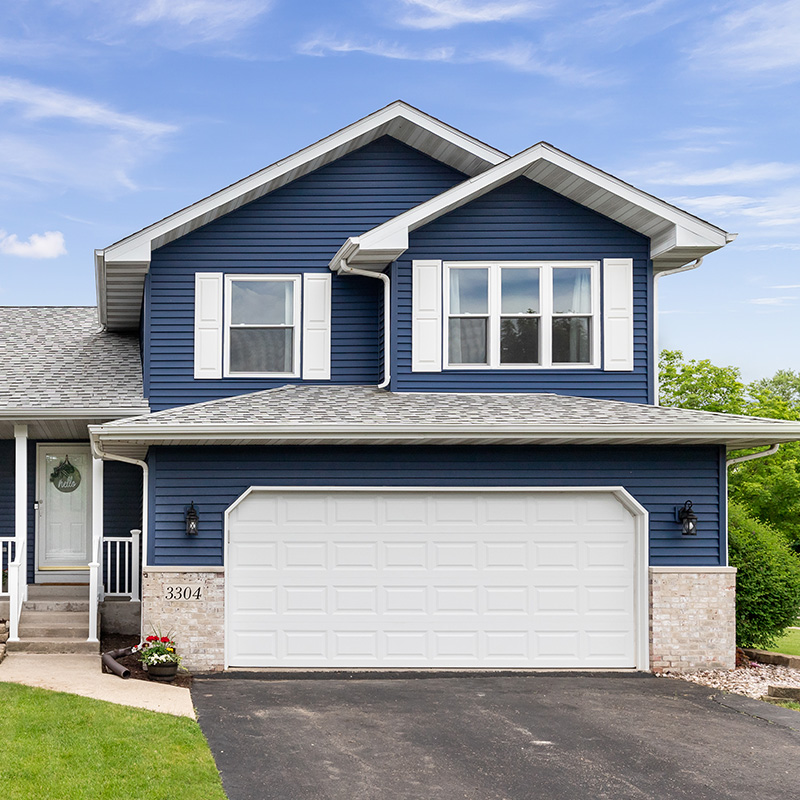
226,489,637,668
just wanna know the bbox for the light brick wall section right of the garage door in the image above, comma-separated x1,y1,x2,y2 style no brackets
650,567,736,672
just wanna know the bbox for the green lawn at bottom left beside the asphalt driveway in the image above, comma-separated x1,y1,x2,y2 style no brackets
0,683,225,800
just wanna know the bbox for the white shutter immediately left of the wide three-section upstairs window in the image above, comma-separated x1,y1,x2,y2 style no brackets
411,261,442,372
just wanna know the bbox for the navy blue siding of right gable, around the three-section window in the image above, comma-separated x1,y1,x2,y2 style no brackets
391,178,654,403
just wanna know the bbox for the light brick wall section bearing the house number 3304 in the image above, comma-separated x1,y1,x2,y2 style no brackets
142,567,225,672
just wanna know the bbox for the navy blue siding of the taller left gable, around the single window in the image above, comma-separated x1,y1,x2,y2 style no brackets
144,137,466,411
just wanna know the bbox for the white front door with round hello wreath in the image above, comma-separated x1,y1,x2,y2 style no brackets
36,444,92,582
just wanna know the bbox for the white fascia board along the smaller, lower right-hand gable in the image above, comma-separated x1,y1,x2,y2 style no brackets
340,142,732,268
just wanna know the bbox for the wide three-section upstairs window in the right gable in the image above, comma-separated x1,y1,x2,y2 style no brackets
444,262,600,369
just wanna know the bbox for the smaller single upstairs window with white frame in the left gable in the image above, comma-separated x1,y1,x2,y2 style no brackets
225,275,300,378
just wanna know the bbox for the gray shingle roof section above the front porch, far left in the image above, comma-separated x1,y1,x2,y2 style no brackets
0,306,148,413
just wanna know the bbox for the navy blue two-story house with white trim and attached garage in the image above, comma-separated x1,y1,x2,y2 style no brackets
0,102,800,670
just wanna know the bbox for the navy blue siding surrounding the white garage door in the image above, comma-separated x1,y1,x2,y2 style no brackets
148,446,725,566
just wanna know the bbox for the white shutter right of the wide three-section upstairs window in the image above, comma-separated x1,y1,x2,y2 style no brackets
603,258,633,372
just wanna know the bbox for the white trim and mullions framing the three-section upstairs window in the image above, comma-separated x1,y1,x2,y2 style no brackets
443,261,601,370
